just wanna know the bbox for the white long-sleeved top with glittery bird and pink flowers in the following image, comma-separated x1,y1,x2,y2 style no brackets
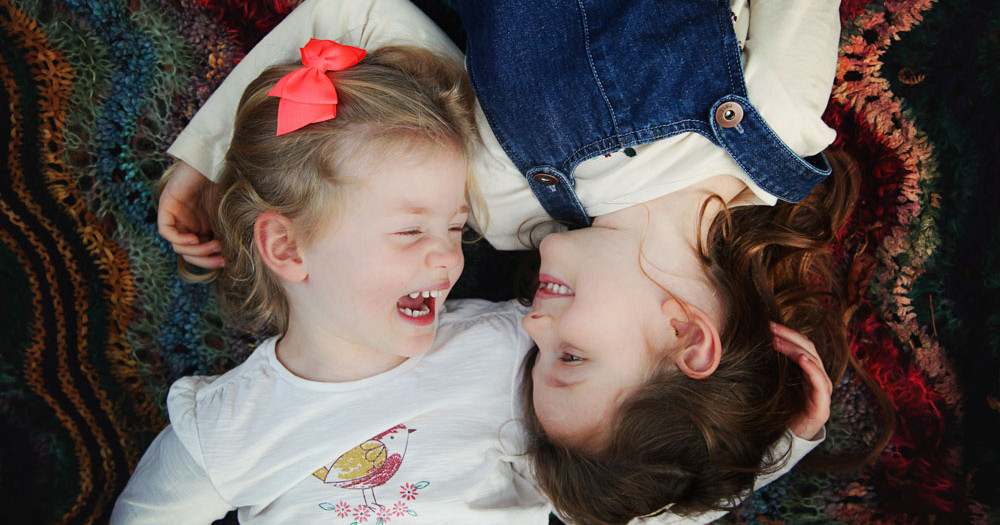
111,300,549,525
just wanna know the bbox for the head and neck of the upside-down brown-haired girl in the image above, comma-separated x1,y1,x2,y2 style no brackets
522,149,880,523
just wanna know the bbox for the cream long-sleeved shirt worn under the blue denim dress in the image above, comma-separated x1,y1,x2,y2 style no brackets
168,0,840,250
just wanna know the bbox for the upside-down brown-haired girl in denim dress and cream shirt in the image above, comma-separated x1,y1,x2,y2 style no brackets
150,1,876,522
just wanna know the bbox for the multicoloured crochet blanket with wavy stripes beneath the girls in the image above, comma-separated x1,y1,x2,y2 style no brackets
0,0,1000,524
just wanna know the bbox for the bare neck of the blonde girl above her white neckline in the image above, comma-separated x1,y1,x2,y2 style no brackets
275,315,407,383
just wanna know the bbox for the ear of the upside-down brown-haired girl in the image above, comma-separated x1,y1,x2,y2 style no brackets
663,299,722,379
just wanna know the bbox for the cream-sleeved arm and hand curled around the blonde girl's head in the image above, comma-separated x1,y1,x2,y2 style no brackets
157,0,462,268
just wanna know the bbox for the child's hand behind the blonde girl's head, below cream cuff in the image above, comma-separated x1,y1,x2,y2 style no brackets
156,161,225,269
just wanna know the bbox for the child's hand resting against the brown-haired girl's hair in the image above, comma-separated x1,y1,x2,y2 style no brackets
771,323,833,440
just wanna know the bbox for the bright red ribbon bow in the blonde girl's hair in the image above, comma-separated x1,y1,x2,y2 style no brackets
268,38,365,135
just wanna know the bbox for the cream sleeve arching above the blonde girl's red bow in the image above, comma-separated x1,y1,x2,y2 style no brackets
167,0,463,181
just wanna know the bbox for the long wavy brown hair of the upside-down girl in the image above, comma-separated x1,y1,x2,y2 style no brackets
523,151,893,524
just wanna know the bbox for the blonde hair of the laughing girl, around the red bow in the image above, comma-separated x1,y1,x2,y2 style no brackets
210,46,485,333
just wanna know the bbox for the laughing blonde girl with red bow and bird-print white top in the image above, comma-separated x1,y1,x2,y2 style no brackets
111,40,564,524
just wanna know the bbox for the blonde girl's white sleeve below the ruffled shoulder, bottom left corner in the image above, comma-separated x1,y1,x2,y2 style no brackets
111,426,233,525
